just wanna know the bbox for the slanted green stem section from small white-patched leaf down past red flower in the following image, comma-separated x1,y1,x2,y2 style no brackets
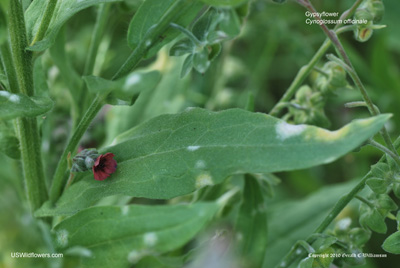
50,95,104,202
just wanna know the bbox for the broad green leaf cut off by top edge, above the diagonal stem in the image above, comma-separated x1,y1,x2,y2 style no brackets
128,0,204,57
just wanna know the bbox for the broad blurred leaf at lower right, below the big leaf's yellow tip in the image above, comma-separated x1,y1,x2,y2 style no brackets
262,181,356,268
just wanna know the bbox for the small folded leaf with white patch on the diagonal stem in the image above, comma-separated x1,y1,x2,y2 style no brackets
83,71,161,105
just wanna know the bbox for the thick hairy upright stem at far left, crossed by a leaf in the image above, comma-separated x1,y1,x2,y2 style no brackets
9,0,47,212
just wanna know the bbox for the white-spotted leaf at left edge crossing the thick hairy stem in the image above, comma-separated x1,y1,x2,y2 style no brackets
0,91,53,120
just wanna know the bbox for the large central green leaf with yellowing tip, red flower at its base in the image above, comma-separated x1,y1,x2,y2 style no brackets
37,108,390,216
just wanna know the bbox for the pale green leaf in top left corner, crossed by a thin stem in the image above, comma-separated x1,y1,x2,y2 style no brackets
25,0,120,51
